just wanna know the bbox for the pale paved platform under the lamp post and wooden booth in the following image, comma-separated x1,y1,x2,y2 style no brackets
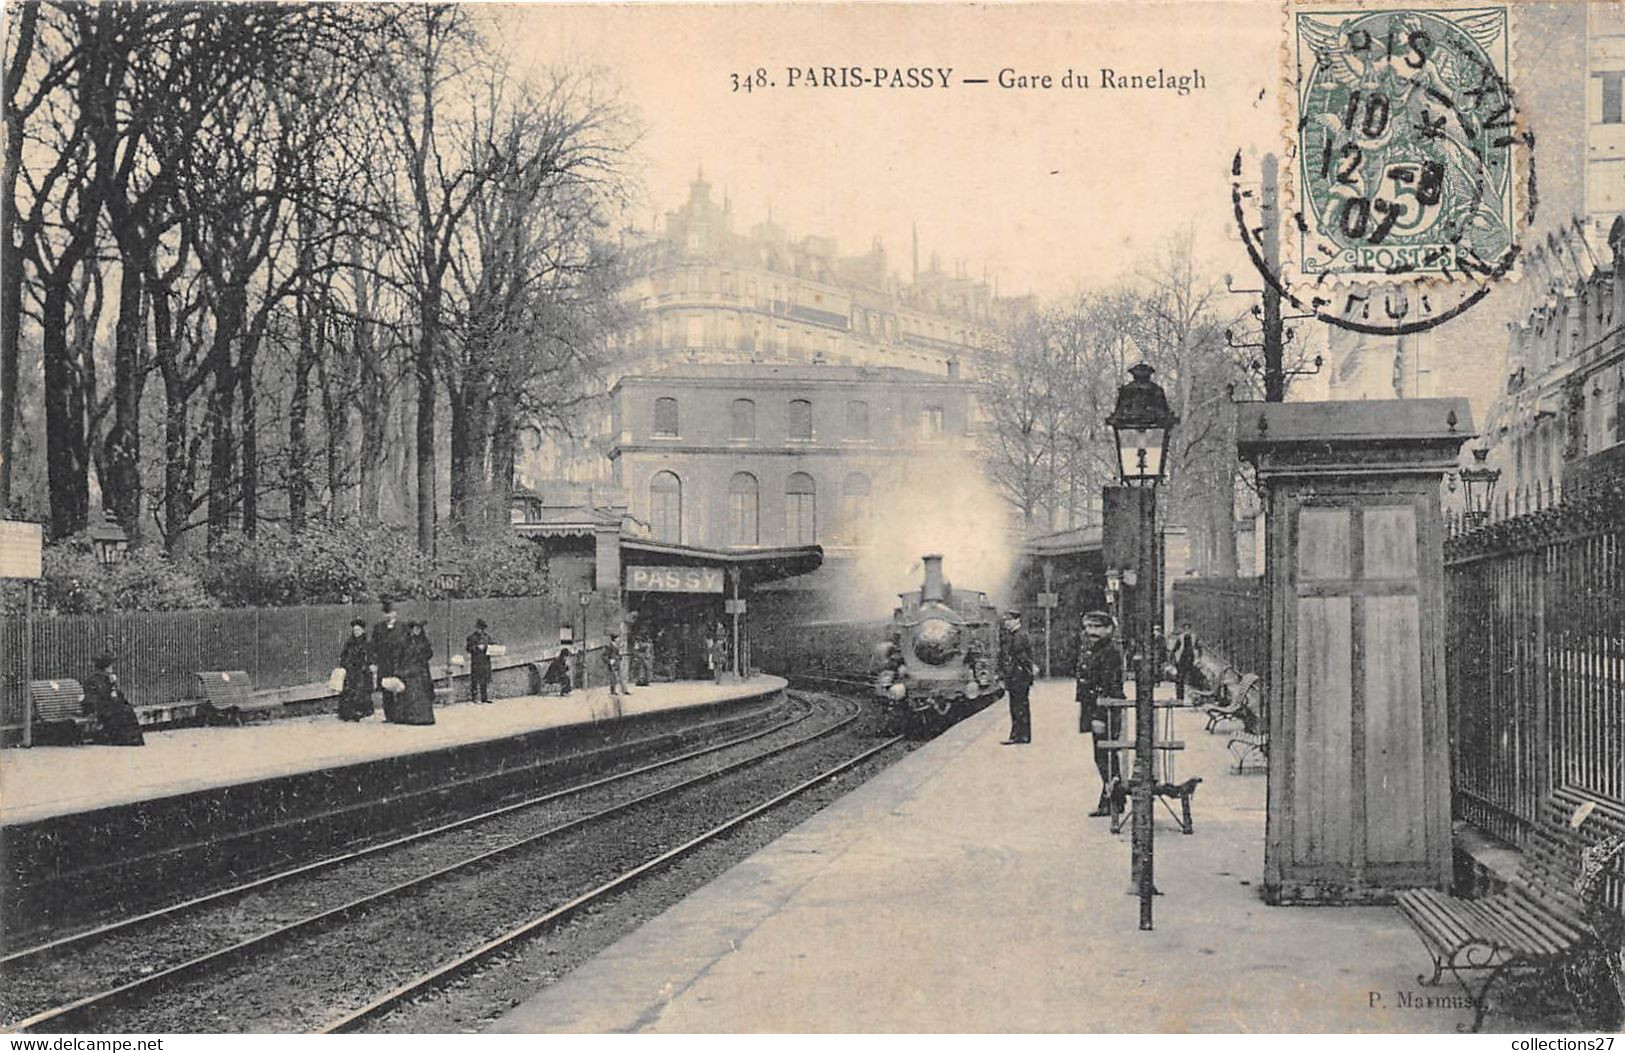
492,681,1472,1034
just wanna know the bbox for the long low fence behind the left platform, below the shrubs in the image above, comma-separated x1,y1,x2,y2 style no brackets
0,590,605,726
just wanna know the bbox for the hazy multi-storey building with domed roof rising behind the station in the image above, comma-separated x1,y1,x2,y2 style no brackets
522,176,1032,501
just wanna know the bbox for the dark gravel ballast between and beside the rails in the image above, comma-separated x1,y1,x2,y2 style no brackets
5,704,877,1030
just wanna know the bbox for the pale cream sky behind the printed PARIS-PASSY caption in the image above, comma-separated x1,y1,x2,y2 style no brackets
497,0,1281,297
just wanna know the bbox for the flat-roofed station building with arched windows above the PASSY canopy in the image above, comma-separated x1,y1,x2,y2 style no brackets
609,364,977,561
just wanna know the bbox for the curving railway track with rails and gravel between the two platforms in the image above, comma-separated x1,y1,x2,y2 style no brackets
0,696,895,1032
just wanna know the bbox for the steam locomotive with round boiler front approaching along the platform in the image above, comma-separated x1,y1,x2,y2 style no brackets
874,554,1004,731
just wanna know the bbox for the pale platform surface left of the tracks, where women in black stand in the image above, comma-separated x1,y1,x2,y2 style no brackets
0,676,785,826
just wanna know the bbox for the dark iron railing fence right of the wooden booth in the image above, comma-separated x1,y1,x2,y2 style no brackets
1445,483,1625,845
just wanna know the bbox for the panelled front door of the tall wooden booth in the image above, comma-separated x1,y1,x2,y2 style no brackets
1284,494,1433,881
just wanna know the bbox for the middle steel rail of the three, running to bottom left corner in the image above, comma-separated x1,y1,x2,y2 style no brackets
0,695,861,1034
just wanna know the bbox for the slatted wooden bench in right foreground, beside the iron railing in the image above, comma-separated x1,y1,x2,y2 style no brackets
1398,790,1625,1032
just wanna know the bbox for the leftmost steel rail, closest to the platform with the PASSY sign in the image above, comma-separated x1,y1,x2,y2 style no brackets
0,695,813,965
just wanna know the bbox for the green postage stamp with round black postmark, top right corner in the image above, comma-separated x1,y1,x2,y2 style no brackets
1284,3,1534,284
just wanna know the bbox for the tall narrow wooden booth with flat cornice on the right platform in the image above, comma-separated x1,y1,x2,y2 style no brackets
1237,398,1472,904
